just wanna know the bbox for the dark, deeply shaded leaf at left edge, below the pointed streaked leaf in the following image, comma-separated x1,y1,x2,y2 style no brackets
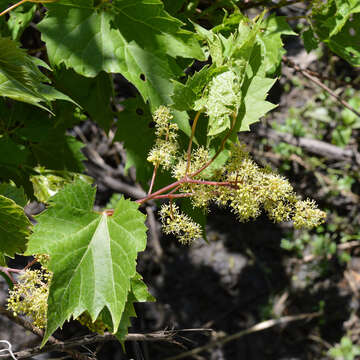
0,101,84,194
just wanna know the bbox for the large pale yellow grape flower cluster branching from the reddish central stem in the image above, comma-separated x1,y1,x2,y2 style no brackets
148,106,326,244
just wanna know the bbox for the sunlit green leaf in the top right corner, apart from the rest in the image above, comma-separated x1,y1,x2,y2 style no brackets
312,0,360,66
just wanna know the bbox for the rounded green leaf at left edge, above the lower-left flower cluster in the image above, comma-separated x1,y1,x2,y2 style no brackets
0,195,31,261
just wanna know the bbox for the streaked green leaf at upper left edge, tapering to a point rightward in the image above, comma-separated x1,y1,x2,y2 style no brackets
0,37,74,112
